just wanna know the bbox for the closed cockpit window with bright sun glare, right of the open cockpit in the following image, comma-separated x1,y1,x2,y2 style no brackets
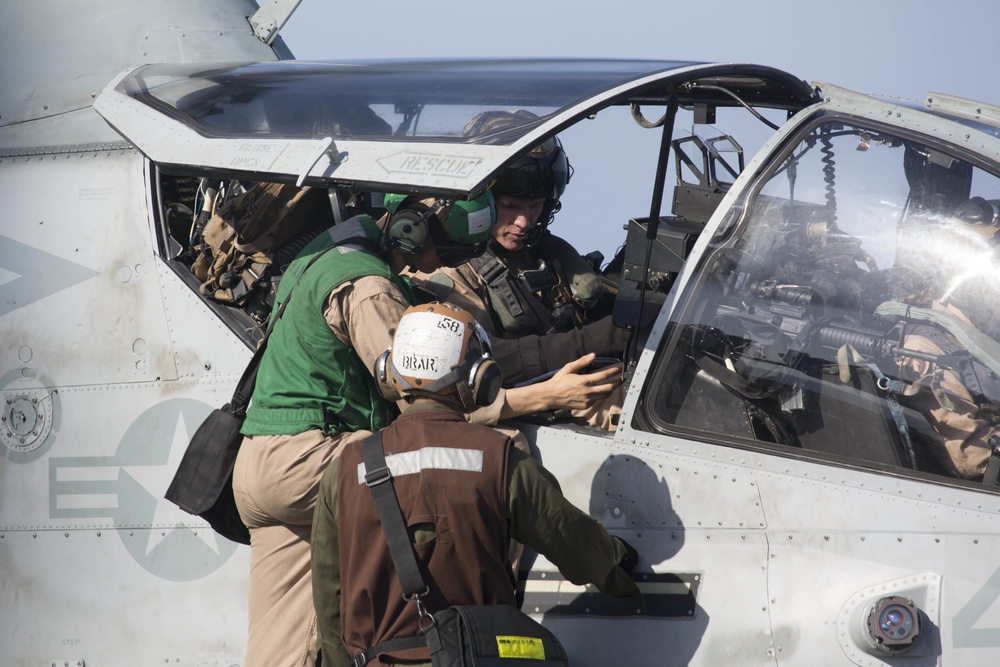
647,117,1000,481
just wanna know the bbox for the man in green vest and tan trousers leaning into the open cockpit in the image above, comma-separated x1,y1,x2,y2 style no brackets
233,193,616,667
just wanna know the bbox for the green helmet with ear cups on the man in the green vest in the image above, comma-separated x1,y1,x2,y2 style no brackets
384,191,497,266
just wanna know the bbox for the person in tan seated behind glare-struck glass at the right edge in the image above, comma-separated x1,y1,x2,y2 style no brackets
884,192,1000,484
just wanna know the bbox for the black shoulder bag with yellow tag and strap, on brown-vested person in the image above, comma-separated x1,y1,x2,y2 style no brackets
353,432,569,667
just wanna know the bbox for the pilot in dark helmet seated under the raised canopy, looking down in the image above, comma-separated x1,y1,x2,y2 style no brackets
410,110,628,430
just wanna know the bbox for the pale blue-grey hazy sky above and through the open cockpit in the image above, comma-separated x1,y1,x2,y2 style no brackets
274,0,1000,259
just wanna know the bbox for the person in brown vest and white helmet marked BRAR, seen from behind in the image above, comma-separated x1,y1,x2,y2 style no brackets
312,303,642,667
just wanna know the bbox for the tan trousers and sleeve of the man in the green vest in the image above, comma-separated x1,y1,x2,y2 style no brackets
233,276,410,667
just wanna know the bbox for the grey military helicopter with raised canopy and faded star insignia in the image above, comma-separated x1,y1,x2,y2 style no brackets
0,0,1000,667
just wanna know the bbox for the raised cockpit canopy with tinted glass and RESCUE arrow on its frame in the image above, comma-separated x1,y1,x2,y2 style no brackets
95,60,815,195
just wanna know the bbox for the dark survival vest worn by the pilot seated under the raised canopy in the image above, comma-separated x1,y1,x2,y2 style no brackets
469,234,603,338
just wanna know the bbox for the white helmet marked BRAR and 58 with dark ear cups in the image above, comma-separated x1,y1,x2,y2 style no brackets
375,303,503,412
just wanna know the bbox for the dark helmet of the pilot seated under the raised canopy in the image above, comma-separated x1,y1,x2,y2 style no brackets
462,109,573,228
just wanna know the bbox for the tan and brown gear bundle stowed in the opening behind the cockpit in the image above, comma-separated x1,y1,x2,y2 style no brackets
191,183,334,305
